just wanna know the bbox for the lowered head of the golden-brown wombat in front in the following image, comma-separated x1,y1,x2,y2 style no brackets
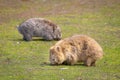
49,46,65,64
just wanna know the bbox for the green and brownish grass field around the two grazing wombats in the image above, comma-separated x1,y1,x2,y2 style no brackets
0,0,120,80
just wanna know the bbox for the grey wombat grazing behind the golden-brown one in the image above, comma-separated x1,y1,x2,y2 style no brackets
17,18,62,41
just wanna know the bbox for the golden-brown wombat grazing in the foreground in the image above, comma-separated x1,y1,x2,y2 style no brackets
49,35,103,66
